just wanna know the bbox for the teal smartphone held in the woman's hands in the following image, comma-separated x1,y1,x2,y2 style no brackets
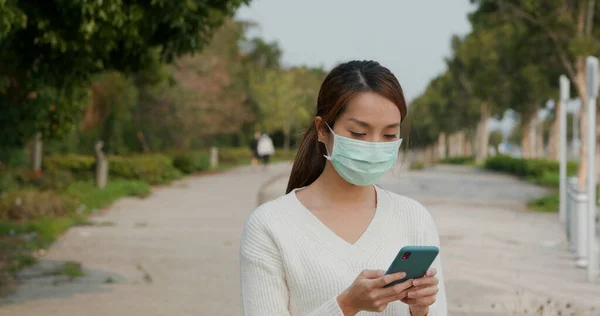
384,246,440,287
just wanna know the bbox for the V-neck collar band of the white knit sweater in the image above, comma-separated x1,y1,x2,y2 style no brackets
289,185,392,264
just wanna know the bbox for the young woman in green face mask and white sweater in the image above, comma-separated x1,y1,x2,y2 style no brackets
240,61,447,316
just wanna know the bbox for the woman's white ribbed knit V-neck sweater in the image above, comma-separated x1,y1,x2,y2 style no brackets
240,187,447,316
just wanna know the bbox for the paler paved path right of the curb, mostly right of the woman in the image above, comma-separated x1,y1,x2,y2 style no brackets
265,163,600,316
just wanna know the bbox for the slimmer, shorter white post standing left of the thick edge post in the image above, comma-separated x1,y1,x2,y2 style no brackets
558,75,570,223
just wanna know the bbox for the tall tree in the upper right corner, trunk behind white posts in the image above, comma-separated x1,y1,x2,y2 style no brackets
471,0,600,186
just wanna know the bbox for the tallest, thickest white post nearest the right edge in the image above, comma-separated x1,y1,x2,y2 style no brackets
581,56,598,281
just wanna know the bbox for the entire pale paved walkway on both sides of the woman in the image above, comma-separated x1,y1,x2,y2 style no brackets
0,164,600,316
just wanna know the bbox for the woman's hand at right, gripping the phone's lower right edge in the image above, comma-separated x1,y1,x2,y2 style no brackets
401,268,439,316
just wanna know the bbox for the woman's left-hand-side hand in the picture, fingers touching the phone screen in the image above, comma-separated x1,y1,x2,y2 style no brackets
338,270,413,316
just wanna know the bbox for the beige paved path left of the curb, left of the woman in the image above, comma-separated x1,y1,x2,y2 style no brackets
0,164,287,316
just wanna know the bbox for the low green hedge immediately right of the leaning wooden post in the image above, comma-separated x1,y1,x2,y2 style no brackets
109,155,181,184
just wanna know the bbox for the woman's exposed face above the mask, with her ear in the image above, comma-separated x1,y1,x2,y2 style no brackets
316,92,401,148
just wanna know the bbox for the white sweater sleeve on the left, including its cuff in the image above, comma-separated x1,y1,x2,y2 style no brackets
240,209,344,316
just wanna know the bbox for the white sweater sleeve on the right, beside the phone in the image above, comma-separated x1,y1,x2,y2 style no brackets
424,213,448,316
